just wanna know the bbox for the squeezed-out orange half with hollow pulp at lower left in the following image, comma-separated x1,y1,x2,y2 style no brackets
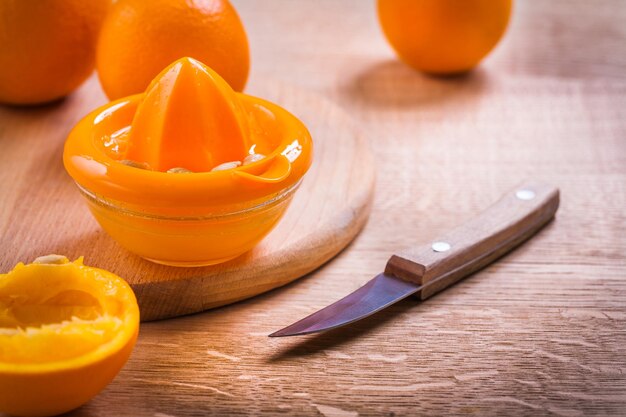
0,256,139,416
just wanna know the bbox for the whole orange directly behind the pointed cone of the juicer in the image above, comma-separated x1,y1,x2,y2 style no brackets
96,0,250,100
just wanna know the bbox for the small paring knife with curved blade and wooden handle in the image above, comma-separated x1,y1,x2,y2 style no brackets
270,182,559,337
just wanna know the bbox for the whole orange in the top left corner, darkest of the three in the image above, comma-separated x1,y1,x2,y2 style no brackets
0,0,110,104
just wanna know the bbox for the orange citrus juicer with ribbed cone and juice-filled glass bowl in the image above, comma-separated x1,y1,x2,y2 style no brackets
63,58,312,266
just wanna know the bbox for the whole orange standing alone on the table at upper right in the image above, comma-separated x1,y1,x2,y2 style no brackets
378,0,512,74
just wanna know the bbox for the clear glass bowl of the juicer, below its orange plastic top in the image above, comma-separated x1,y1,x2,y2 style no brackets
77,182,300,267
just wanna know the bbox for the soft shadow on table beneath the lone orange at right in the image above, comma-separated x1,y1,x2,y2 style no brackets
339,59,489,111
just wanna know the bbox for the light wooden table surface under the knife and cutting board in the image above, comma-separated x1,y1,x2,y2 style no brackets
0,0,626,417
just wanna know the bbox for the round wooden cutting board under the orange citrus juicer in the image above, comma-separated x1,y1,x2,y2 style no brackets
0,77,374,321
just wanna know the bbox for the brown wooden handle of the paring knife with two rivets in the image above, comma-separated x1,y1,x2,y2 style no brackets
385,182,559,300
